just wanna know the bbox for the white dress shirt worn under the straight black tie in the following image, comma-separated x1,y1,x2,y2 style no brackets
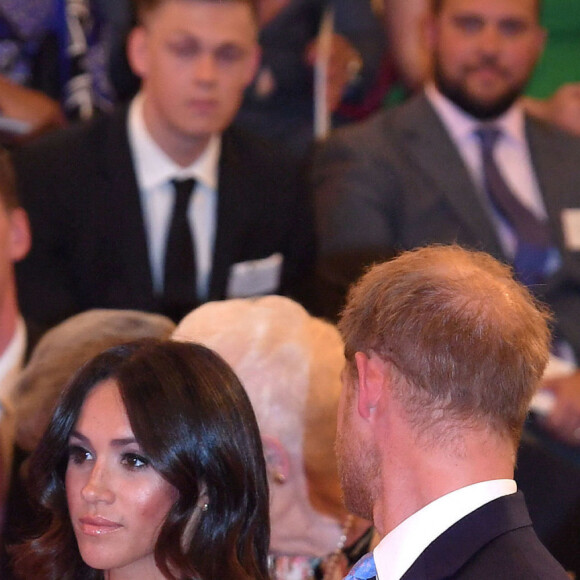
128,94,221,300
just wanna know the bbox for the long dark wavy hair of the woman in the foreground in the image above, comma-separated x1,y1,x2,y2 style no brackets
13,339,270,580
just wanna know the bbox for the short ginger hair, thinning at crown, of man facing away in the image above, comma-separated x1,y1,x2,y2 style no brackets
339,246,550,442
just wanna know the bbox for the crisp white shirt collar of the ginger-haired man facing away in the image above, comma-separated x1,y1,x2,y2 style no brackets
373,479,517,580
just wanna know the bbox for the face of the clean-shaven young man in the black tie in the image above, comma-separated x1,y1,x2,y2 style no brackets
129,0,259,154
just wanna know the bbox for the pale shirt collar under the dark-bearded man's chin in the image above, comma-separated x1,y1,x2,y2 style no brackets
425,82,526,146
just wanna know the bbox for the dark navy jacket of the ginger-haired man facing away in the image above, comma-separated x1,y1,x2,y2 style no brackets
390,492,568,580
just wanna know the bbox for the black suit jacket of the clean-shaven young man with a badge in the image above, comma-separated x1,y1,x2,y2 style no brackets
14,109,315,325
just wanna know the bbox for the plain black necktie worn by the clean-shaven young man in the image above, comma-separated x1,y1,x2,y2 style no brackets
163,179,197,320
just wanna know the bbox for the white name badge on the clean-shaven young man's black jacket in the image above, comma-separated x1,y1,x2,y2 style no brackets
226,253,284,298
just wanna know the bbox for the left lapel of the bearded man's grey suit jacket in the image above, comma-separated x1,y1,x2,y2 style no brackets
401,95,503,256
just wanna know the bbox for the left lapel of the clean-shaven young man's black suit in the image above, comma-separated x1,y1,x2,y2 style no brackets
102,108,153,297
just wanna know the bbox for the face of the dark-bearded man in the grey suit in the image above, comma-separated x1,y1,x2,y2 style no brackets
432,0,544,118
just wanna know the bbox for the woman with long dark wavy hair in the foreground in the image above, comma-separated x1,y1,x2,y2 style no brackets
14,340,269,580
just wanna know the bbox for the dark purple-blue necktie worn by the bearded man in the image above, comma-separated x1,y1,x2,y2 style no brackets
476,127,552,286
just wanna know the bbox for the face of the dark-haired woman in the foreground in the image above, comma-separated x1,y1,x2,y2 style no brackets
66,380,178,579
